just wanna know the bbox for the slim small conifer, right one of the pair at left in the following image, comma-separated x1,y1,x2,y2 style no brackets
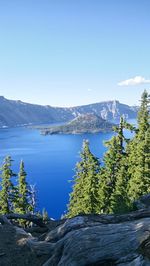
15,161,31,214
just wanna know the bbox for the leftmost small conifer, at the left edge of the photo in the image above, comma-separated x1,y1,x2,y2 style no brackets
0,156,16,214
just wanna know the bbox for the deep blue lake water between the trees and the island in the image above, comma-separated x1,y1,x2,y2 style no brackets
0,121,136,219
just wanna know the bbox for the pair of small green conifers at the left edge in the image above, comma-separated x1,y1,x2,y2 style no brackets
0,156,34,216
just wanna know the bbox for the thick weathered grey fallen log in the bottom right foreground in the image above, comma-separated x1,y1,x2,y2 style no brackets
43,217,150,266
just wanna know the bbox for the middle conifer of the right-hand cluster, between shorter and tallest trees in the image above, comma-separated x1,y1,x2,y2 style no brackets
99,117,134,213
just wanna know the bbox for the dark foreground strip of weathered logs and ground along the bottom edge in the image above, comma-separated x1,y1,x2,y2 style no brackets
0,209,150,266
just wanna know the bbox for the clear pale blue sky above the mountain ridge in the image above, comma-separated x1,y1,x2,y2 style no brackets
0,0,150,106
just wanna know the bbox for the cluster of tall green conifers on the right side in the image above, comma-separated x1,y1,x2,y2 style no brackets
68,91,150,217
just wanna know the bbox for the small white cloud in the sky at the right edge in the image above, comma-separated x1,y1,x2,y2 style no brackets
118,76,150,86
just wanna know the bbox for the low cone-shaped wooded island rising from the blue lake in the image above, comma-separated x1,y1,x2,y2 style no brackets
41,113,114,135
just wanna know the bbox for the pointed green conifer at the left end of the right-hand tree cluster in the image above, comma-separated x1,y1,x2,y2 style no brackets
67,141,100,217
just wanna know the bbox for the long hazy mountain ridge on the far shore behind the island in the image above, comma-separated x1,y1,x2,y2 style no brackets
0,96,138,128
